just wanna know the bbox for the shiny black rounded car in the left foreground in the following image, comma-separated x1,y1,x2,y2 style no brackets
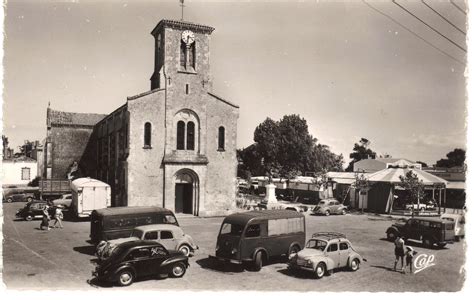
92,240,189,286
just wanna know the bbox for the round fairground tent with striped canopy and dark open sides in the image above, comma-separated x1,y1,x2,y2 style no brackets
367,166,447,213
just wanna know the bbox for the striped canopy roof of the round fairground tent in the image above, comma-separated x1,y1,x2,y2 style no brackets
368,168,447,185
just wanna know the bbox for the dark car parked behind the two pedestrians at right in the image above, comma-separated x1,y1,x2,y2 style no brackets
386,217,454,248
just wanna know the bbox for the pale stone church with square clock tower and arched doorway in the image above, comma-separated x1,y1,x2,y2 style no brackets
46,20,239,216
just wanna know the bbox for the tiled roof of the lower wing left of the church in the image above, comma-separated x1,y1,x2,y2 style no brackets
47,108,107,126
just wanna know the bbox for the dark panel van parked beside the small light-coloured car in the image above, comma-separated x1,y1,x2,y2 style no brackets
211,209,306,271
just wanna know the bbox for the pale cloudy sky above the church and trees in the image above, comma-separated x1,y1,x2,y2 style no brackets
3,0,467,165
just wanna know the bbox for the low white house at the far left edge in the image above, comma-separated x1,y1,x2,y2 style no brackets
1,156,38,186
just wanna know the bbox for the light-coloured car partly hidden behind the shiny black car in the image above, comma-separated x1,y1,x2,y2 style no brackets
96,224,199,259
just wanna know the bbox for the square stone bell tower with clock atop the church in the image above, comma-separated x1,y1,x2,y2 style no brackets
150,20,214,90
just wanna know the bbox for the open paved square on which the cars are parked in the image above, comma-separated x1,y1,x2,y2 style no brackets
3,203,465,292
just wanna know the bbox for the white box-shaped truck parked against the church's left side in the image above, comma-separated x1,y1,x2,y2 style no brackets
70,177,111,217
